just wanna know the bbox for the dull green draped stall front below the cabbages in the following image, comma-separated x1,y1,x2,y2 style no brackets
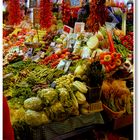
32,112,104,140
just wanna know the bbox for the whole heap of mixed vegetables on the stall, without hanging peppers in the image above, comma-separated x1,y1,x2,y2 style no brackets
3,16,133,131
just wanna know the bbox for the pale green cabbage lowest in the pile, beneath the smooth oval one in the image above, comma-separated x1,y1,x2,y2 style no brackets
25,109,49,126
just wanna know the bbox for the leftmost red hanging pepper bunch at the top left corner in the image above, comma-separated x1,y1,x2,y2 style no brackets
8,0,22,25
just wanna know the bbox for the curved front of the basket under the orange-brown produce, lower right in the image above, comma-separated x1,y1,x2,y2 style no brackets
103,104,126,119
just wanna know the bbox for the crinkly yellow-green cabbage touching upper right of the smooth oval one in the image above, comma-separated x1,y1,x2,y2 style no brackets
38,88,58,106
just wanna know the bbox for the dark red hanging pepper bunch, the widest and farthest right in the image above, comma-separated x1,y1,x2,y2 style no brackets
87,0,108,32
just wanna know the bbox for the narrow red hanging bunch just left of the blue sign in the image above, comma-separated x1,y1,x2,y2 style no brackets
61,0,71,24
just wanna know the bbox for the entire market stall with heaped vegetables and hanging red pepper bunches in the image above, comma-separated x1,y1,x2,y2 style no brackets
3,0,135,140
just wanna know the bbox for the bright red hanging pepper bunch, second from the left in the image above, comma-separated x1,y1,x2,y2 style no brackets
40,0,53,29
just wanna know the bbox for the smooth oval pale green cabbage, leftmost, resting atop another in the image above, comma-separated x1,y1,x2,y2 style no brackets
24,97,42,110
